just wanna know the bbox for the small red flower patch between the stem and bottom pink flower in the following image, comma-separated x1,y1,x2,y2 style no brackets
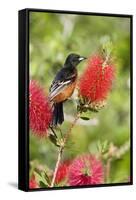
55,161,71,184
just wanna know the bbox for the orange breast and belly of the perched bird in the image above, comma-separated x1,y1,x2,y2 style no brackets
53,80,76,103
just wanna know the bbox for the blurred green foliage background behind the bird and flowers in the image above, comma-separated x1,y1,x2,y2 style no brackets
30,12,130,183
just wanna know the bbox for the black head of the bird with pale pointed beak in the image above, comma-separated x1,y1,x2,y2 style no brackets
64,53,86,67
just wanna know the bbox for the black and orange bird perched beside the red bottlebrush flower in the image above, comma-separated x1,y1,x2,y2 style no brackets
49,53,86,126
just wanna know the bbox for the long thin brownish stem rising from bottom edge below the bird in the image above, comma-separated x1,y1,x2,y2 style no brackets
50,113,80,187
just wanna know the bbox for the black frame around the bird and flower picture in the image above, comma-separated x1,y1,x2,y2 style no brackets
18,8,133,191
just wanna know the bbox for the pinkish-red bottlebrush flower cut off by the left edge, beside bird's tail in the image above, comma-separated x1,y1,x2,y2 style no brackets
29,81,52,137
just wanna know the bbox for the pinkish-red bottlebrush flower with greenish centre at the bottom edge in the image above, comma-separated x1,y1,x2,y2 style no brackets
68,154,103,186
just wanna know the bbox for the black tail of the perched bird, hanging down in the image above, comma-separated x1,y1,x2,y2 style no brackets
51,102,64,126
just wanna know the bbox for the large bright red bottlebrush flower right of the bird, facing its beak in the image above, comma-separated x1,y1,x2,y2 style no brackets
79,56,115,102
